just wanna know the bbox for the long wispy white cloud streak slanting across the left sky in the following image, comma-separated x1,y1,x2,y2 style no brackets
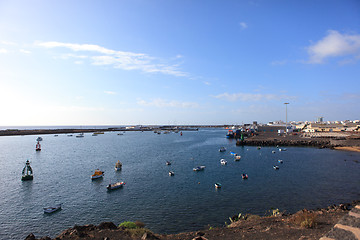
36,42,188,77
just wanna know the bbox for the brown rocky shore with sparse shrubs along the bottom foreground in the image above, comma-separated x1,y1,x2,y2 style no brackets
25,201,360,240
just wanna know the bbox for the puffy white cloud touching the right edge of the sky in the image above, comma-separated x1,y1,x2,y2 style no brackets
307,30,360,64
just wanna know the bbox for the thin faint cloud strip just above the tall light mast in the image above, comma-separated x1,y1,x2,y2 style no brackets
214,93,296,102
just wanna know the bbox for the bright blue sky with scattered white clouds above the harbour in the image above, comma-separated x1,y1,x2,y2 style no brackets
0,0,360,126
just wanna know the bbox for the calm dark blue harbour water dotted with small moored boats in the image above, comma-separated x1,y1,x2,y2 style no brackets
0,130,360,239
